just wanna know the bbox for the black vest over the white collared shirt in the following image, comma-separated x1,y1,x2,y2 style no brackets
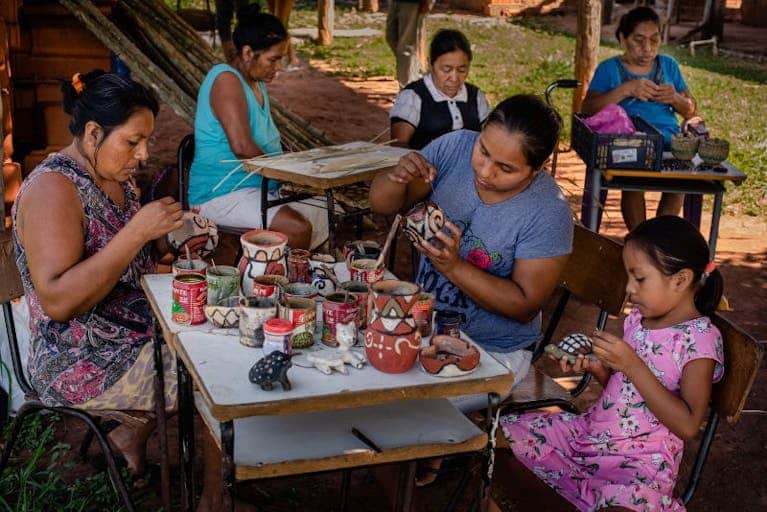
405,79,480,149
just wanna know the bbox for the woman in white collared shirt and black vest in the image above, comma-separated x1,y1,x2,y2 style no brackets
389,30,490,149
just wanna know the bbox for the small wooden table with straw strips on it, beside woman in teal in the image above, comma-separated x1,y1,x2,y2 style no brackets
244,142,411,252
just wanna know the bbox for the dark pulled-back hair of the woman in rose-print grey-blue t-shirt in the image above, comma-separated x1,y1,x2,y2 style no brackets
485,94,562,170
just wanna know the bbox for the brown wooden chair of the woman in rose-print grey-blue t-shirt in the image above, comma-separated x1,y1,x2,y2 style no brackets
501,224,628,412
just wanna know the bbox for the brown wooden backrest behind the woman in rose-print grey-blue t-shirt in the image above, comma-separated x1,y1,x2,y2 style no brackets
559,224,628,315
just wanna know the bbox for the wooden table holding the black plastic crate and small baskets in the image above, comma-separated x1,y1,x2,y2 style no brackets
583,157,746,259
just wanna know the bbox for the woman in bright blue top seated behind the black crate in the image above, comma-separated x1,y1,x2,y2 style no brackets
583,7,696,231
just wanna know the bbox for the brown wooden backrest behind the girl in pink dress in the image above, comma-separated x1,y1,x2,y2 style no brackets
711,314,764,424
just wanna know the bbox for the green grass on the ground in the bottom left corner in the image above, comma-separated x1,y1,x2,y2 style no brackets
0,414,132,512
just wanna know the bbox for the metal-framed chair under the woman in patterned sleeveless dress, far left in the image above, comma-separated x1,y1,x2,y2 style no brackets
0,233,136,512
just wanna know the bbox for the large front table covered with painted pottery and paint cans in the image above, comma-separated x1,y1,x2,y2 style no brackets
142,268,514,510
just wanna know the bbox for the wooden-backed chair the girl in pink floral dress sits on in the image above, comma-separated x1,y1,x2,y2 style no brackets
492,314,764,510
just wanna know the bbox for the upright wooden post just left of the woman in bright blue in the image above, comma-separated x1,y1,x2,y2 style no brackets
573,0,602,112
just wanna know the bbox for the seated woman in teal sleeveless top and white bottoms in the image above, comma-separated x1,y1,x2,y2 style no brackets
189,4,327,248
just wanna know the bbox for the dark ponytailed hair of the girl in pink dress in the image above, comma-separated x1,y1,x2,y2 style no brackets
626,215,724,315
